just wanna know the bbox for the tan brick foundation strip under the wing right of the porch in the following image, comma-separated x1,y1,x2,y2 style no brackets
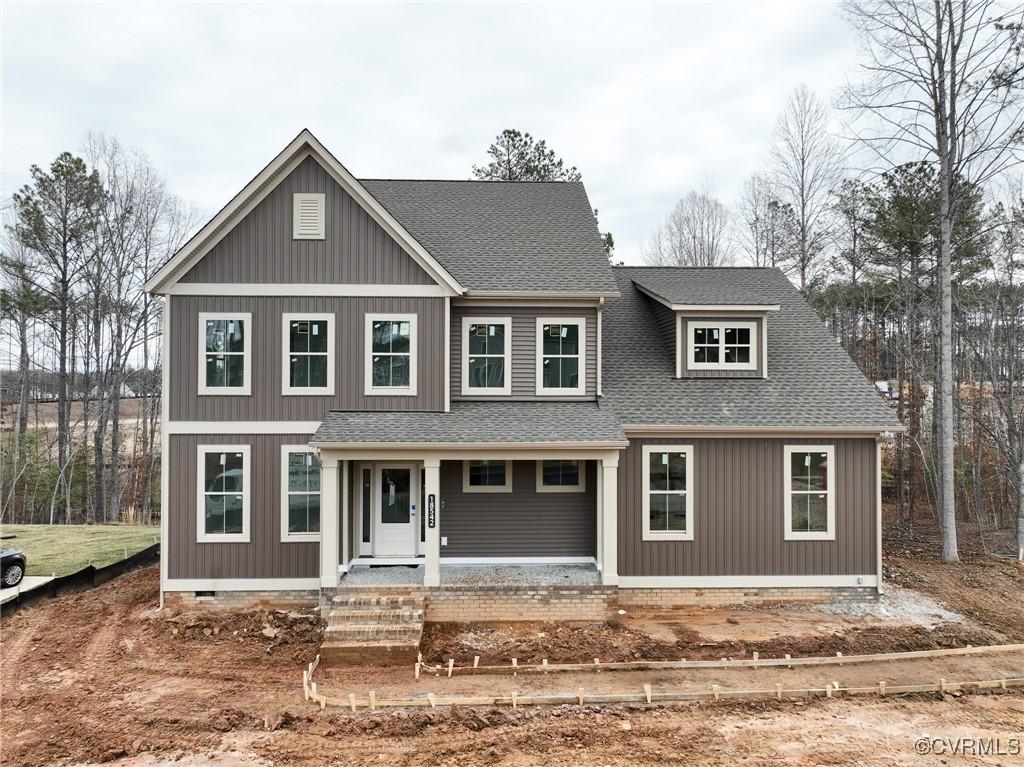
617,586,879,609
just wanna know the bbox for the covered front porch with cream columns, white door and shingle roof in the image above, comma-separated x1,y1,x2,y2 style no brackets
311,402,625,589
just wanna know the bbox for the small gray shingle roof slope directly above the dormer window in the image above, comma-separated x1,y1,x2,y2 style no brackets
633,267,777,304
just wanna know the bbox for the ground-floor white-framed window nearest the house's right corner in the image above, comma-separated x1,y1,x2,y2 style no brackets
783,444,836,541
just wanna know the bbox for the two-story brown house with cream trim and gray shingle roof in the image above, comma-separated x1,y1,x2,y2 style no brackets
147,131,900,617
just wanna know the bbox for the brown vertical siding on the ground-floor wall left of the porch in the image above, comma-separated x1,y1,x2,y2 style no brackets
166,434,319,580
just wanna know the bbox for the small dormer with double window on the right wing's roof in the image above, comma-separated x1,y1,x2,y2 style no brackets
633,269,779,378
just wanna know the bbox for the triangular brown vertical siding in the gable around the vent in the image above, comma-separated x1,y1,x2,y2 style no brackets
181,158,433,285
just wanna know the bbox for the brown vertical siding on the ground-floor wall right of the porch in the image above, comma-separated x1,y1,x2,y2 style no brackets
618,436,878,576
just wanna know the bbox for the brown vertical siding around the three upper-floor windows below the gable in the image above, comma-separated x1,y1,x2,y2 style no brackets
169,296,445,421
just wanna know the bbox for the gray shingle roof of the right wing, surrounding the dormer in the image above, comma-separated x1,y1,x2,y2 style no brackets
603,267,899,430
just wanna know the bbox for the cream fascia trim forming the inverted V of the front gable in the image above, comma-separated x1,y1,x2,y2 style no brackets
145,129,466,294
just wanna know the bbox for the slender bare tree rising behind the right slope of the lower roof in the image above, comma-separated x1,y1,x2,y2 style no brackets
771,85,843,292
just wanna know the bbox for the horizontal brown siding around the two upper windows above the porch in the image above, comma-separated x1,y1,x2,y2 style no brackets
451,303,598,399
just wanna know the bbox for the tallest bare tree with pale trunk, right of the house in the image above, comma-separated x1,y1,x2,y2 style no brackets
845,0,1024,562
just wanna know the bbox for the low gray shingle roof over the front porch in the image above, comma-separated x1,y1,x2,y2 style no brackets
310,401,626,445
